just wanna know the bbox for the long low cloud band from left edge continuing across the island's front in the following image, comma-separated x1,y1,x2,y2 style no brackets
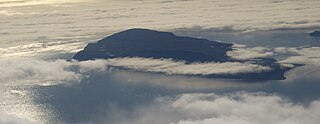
0,58,270,82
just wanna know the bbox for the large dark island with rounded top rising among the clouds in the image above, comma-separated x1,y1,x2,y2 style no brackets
72,29,289,80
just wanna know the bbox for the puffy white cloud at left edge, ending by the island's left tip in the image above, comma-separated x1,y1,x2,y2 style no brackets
0,60,80,82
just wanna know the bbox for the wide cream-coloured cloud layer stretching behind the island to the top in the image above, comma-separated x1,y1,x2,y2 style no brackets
0,0,320,56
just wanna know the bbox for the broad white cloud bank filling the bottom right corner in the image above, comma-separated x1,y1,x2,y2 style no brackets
107,92,320,124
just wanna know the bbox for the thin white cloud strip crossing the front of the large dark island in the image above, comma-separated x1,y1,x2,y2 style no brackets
103,58,271,75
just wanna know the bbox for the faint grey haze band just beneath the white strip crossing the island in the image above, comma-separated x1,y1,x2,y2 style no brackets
110,70,266,91
